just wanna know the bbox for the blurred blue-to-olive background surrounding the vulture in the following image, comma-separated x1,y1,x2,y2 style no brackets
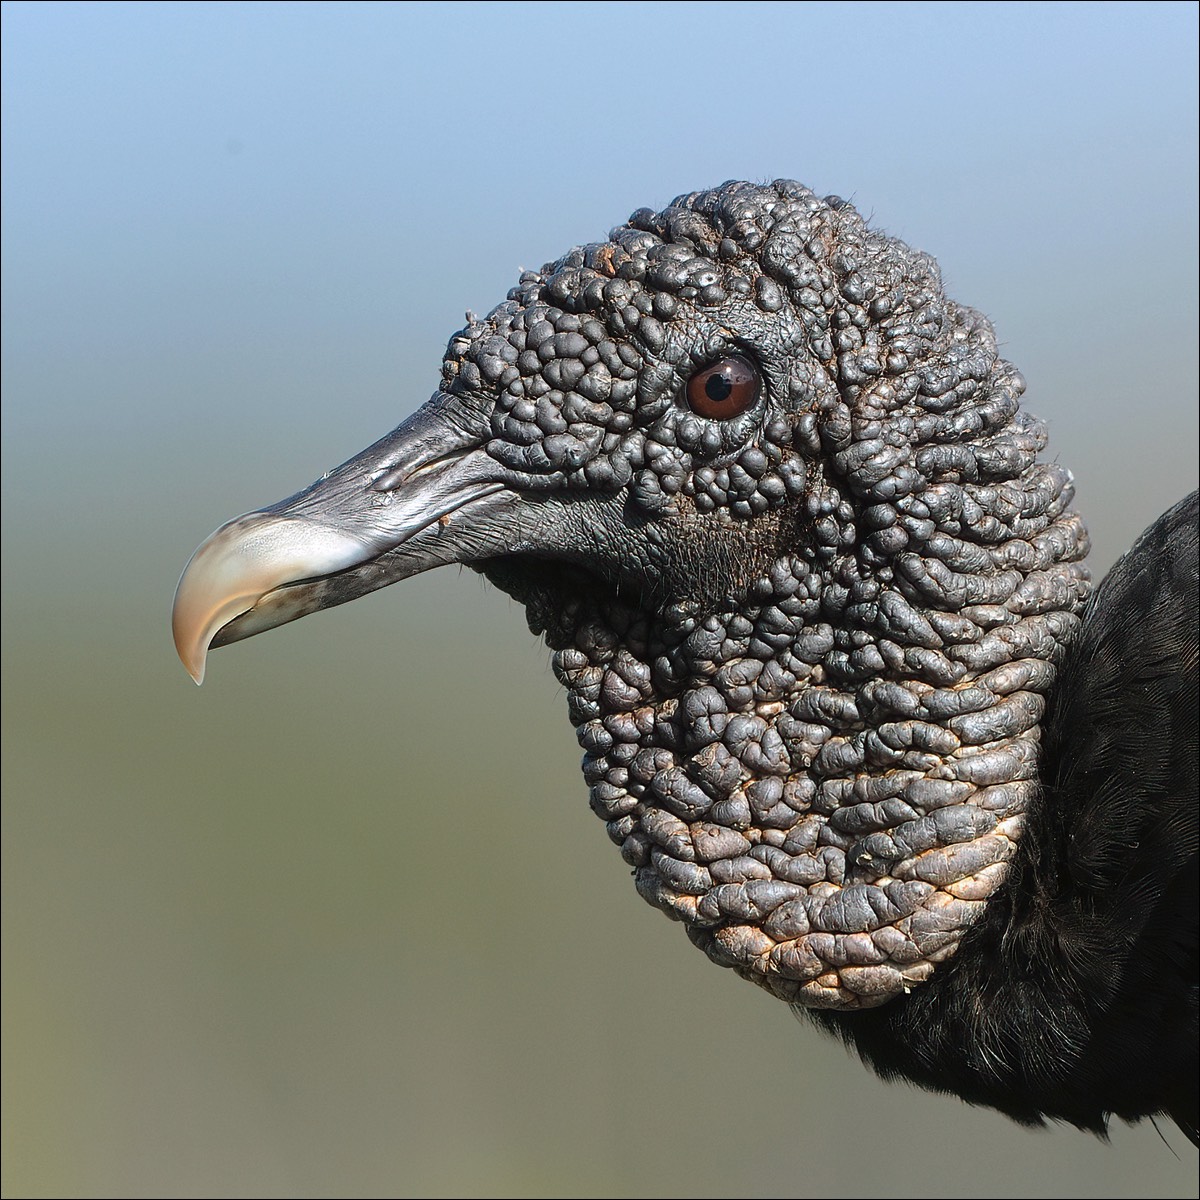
2,2,1196,1196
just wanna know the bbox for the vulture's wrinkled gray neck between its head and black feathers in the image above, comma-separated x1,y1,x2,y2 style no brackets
488,472,1087,1009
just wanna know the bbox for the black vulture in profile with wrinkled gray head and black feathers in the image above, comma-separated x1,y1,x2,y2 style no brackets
174,181,1198,1141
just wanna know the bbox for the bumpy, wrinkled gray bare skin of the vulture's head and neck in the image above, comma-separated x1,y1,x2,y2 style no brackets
182,181,1088,1009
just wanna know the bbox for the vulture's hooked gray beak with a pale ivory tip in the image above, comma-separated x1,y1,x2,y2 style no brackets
172,395,520,684
